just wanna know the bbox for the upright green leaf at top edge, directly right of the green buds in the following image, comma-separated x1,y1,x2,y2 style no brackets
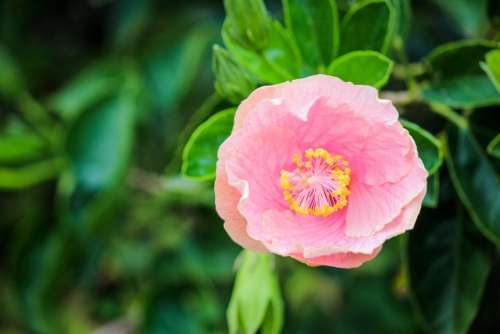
283,0,339,67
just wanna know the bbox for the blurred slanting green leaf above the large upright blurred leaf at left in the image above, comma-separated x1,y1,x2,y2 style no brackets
49,60,123,120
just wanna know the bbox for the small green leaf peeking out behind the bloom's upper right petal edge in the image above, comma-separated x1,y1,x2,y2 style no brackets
401,119,444,175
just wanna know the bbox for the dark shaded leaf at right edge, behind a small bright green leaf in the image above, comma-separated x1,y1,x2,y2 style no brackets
422,40,500,108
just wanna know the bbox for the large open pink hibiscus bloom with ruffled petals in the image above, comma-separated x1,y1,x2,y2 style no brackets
215,75,427,268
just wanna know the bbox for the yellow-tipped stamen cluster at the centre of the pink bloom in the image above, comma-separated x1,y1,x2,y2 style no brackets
280,148,351,217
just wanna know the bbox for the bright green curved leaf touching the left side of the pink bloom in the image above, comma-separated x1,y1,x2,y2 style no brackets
182,108,236,180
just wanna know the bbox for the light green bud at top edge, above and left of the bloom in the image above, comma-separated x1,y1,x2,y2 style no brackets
224,0,272,50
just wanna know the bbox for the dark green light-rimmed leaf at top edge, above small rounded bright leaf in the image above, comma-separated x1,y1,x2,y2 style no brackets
340,0,396,54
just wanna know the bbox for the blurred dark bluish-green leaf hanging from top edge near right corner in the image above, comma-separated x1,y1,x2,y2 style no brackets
432,0,489,37
